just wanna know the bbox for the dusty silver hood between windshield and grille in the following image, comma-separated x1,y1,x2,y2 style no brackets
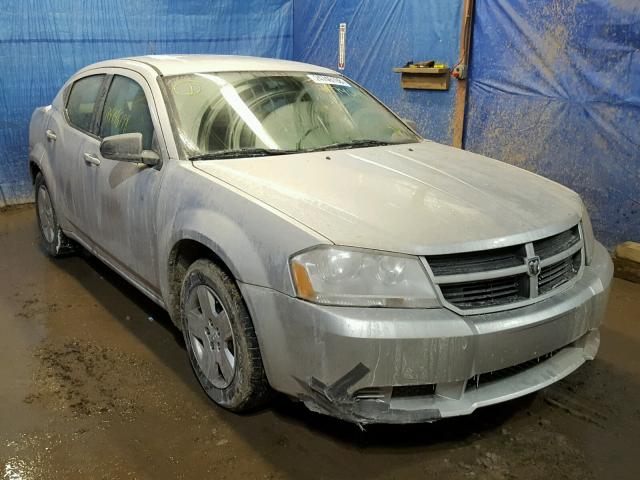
194,141,582,255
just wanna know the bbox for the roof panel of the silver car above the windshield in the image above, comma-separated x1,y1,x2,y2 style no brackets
82,55,336,76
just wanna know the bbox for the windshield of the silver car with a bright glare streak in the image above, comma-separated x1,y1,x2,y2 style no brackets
164,72,420,158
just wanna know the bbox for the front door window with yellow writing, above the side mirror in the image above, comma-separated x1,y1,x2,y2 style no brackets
100,75,153,150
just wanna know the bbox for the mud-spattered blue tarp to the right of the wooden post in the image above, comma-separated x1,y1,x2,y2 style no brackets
465,0,640,247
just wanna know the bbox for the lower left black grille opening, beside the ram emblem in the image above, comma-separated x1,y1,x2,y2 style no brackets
440,275,526,309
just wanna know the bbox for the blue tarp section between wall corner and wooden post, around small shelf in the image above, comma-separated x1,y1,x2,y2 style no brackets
293,0,462,143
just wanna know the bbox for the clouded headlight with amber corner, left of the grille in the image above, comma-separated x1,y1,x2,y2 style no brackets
291,247,439,308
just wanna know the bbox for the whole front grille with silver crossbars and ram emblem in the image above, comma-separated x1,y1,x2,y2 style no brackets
426,225,582,313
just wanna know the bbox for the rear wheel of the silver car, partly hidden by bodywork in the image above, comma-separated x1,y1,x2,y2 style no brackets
35,173,76,257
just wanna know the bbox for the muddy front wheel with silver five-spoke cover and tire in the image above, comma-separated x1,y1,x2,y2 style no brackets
180,259,272,412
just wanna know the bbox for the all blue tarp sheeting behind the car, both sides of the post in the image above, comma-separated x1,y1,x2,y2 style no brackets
0,0,640,247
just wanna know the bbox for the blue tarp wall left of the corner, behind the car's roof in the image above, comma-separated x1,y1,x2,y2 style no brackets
0,0,293,207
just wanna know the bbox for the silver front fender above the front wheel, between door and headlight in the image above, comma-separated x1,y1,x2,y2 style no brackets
152,162,330,316
